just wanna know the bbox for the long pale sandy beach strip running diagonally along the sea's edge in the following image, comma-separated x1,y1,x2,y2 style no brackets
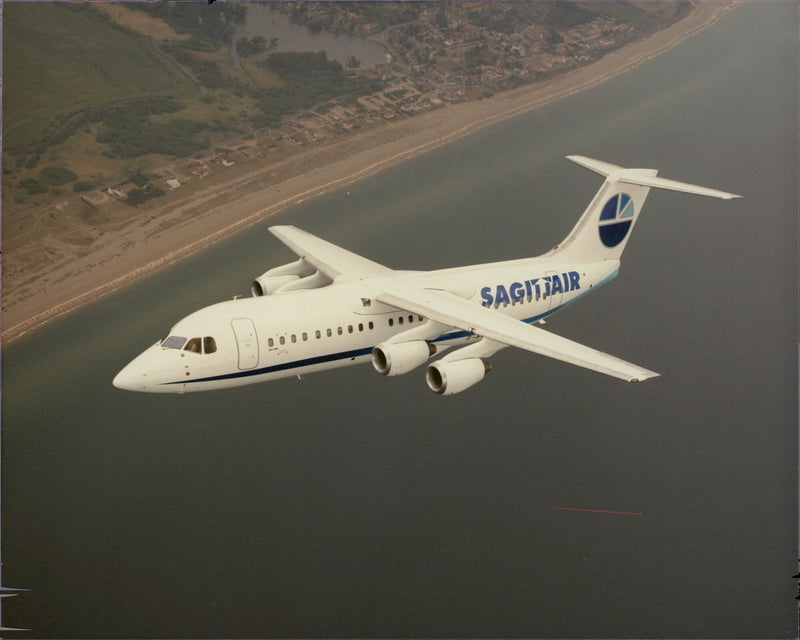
2,2,738,344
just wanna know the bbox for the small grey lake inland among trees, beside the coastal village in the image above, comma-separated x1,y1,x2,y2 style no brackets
231,2,387,69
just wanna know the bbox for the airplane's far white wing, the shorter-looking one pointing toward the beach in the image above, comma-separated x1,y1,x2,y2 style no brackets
269,225,392,280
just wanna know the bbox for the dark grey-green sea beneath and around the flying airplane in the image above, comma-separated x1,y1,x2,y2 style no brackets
2,3,798,637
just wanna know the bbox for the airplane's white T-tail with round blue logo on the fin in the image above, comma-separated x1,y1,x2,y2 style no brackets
549,156,740,262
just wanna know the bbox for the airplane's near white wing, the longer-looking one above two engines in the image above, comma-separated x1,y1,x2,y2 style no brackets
377,286,659,382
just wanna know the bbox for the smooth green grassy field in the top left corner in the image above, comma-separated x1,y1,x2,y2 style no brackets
3,2,199,154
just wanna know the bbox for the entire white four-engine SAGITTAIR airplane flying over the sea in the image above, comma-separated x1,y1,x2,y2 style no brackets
113,155,740,395
